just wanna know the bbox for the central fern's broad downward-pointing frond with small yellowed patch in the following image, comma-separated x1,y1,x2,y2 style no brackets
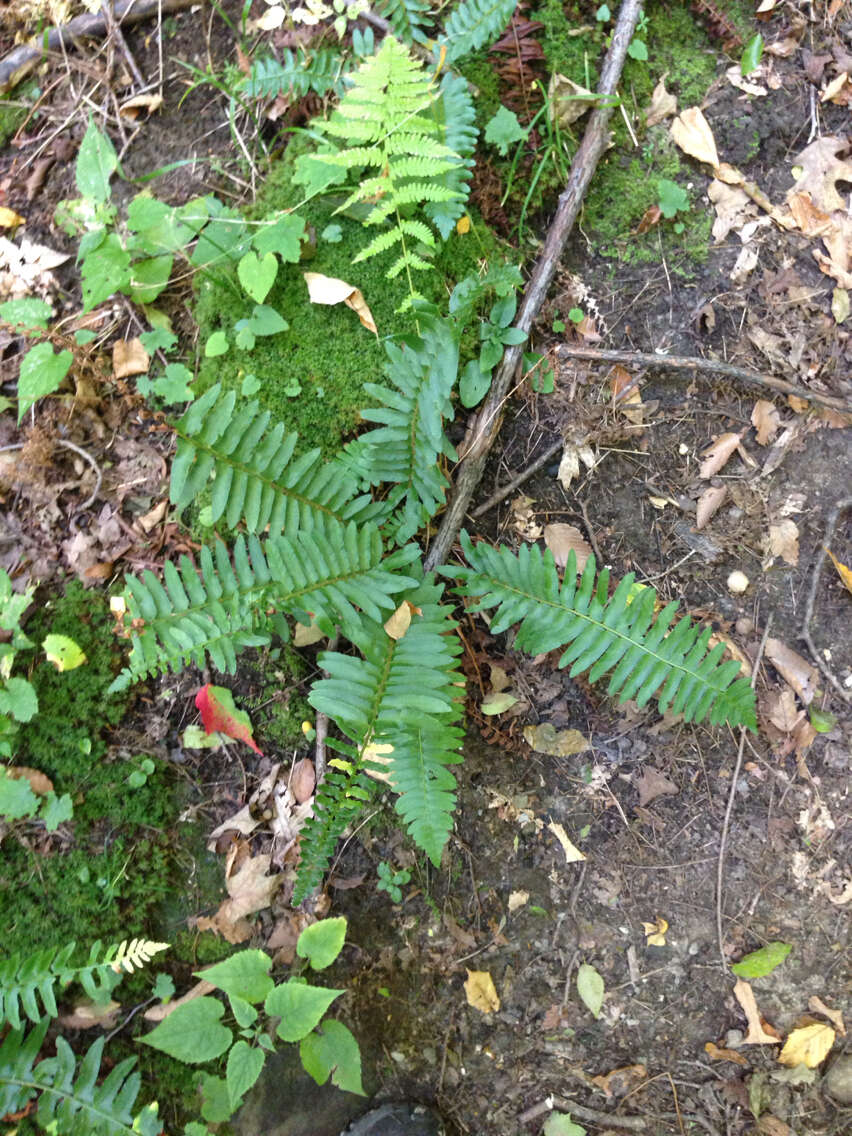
309,584,463,866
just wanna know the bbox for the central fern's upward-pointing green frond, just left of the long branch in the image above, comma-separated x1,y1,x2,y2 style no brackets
346,312,459,542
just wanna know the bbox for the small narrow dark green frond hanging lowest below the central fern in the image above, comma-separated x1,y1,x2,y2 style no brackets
293,763,373,907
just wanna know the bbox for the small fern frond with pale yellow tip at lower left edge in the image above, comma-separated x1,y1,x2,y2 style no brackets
0,938,167,1031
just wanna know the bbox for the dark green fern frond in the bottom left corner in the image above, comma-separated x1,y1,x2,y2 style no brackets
0,1018,161,1136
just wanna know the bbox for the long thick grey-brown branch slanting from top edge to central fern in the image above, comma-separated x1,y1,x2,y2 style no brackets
425,0,642,571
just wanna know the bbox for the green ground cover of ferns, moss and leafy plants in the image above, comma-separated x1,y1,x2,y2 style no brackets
0,0,849,1136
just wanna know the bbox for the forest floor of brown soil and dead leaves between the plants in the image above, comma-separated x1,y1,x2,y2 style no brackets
0,5,852,1136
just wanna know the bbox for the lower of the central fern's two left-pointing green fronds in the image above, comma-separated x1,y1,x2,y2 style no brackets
110,521,417,691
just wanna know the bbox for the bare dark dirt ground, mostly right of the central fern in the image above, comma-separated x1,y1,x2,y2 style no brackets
0,5,852,1136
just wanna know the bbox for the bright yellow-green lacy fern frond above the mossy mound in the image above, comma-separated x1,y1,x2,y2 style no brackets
296,35,463,311
